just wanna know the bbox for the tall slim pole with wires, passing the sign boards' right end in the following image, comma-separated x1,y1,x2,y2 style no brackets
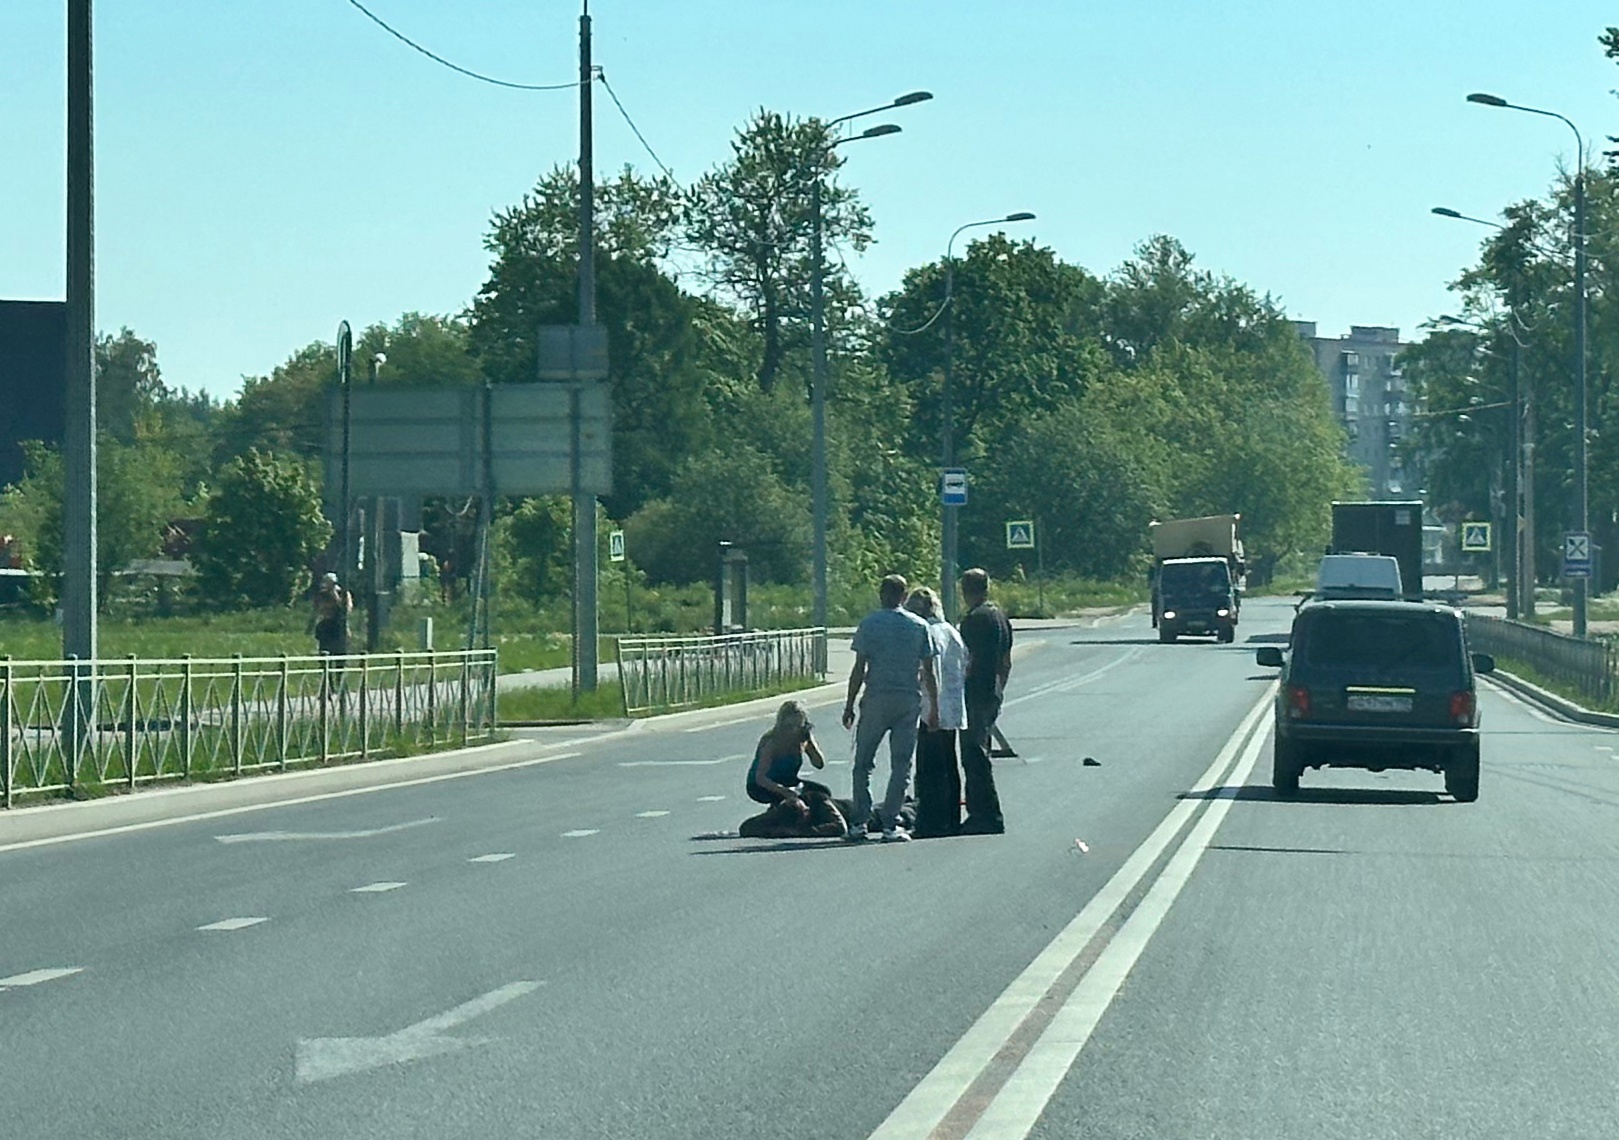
572,0,597,700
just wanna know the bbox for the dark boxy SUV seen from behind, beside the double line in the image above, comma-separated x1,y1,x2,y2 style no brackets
1258,601,1496,803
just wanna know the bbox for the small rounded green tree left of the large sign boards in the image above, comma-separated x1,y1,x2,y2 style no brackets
191,449,332,609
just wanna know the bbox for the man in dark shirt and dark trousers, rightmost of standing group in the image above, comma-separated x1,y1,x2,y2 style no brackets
960,568,1012,836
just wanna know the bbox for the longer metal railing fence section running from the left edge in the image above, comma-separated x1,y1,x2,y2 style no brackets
0,649,495,806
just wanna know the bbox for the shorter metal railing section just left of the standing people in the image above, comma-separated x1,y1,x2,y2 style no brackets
618,630,826,716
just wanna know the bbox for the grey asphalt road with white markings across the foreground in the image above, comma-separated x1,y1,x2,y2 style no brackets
0,601,1619,1140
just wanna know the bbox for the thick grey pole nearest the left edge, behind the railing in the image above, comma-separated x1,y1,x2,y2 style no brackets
62,0,97,785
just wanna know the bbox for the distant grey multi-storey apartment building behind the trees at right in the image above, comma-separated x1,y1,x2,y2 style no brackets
1294,321,1420,499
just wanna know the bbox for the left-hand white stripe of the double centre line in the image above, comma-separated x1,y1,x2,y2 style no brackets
871,682,1276,1140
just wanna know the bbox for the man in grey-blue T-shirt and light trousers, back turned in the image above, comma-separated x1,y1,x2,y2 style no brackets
843,573,939,842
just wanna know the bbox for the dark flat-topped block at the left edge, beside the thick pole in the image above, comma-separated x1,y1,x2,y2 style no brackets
0,301,68,486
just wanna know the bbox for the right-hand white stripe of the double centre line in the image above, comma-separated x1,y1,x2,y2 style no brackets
967,712,1268,1140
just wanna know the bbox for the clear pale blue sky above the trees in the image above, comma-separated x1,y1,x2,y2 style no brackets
0,0,1619,395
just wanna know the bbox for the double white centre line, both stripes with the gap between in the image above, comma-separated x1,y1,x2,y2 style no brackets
871,685,1274,1140
